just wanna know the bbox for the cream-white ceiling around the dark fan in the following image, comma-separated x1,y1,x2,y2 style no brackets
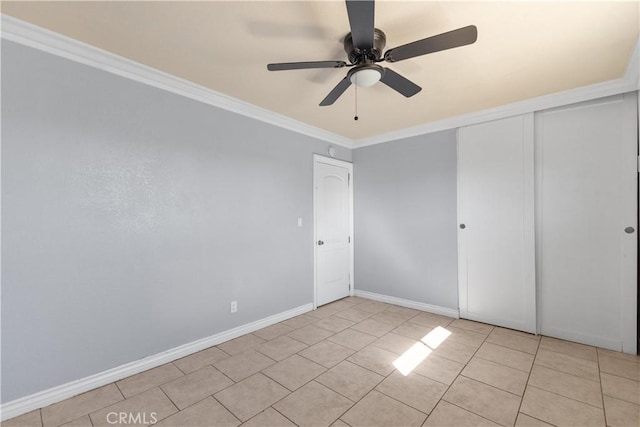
2,0,640,139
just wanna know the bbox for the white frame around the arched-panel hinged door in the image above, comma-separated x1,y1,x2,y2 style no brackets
312,154,355,310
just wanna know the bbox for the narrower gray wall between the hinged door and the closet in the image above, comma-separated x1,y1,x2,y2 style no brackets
353,130,458,309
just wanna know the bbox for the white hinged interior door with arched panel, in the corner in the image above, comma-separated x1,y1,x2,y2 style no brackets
314,156,352,306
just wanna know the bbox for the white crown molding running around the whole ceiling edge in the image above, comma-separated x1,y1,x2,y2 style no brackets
0,15,640,149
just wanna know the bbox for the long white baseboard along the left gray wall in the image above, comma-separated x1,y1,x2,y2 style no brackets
0,303,313,421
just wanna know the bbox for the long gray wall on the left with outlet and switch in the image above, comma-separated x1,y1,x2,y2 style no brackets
1,41,351,402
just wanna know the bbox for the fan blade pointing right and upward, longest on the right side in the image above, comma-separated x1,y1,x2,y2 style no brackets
384,25,478,62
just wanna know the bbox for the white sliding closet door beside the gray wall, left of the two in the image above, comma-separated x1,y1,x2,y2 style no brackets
458,114,536,333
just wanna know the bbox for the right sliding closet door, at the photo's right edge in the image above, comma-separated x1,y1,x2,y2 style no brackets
536,94,638,353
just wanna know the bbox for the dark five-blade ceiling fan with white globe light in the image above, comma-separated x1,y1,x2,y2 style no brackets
267,0,478,107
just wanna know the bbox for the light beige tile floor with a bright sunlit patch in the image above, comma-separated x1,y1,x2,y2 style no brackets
2,297,640,427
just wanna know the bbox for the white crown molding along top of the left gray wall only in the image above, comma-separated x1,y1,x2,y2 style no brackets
0,14,353,148
